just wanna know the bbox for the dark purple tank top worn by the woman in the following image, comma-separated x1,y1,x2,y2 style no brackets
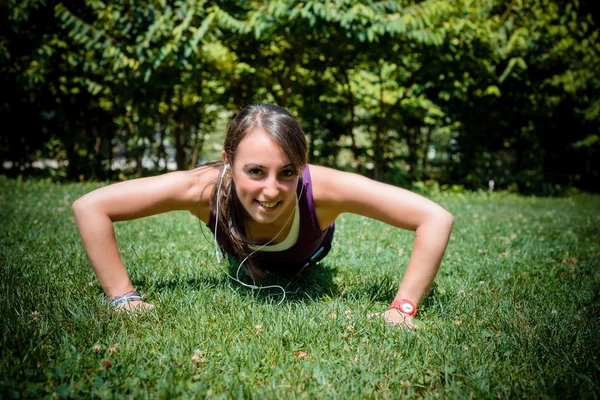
208,164,335,264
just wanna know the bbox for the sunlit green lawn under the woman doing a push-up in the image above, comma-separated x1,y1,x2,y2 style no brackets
0,177,600,399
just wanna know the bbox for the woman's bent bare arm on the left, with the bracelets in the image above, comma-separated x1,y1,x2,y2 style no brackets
72,168,218,308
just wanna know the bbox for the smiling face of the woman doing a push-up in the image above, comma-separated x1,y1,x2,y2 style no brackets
226,128,299,224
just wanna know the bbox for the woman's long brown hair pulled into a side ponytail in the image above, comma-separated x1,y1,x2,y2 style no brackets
210,104,308,279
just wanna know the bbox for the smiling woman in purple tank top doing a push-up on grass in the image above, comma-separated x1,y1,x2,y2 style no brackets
73,104,453,327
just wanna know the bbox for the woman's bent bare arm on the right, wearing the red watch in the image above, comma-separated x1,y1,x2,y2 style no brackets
311,165,454,327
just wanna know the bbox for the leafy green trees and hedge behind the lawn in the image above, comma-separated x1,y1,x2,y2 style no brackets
0,0,600,194
